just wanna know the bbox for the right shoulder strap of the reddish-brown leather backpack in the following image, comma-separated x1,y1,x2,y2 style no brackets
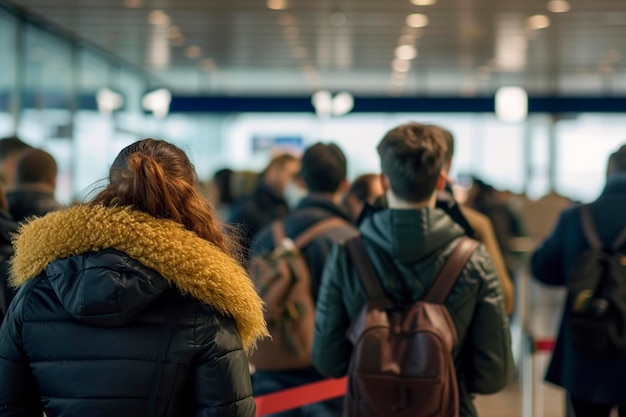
424,236,480,304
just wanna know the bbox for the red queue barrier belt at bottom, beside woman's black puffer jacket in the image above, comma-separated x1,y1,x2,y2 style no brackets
254,377,348,417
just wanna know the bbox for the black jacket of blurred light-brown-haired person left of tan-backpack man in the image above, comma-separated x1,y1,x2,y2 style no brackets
228,181,289,254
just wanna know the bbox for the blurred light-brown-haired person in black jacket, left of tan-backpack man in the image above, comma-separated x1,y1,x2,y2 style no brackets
228,154,300,260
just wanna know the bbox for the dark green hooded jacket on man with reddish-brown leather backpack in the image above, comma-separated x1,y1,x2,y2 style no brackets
312,208,514,417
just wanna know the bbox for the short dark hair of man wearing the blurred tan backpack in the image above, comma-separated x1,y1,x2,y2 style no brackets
301,143,348,193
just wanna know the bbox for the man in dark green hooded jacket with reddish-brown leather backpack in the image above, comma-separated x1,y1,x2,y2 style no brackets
312,123,514,417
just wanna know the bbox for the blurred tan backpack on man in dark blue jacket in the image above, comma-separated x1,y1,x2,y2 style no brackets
249,217,349,370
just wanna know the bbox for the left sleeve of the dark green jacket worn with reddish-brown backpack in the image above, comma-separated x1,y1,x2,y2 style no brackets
311,245,352,378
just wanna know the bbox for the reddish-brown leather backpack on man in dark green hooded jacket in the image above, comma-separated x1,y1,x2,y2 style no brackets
345,237,479,417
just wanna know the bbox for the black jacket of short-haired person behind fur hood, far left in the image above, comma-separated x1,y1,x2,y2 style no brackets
7,184,63,223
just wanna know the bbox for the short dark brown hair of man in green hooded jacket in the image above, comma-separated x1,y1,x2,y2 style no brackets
378,123,448,203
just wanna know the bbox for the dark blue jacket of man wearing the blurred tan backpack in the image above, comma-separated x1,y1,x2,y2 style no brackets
250,196,358,301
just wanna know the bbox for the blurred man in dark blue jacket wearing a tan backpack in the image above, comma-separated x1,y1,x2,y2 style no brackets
250,143,358,417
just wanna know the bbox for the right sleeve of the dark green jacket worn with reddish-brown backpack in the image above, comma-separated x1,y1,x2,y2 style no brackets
464,246,514,394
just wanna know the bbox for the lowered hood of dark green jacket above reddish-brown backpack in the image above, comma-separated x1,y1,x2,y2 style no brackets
361,207,464,263
